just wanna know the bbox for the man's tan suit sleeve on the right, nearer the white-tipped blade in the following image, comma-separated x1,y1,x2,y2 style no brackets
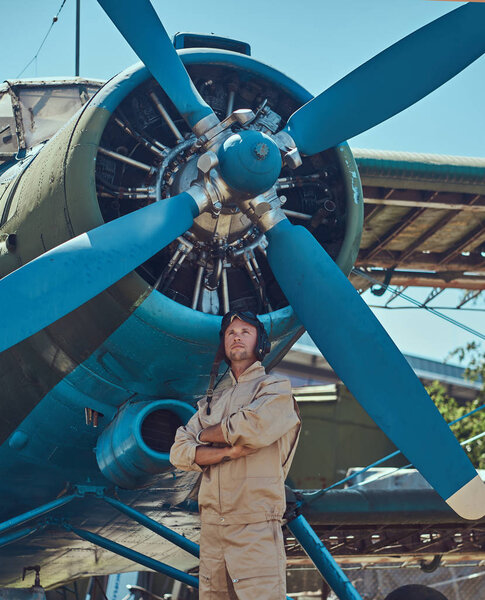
221,379,294,448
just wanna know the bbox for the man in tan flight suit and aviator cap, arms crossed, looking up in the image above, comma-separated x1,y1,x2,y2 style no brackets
170,311,300,600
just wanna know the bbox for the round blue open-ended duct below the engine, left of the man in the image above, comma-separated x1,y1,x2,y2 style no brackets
96,400,195,489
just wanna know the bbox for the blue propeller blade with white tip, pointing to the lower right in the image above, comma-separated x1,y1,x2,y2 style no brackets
266,220,485,519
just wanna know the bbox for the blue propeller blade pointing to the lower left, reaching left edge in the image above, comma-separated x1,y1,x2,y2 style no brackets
0,192,199,352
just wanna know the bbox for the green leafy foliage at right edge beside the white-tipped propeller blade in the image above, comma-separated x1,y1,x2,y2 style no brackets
426,342,485,469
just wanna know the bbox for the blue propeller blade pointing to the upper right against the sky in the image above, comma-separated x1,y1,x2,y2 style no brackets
285,3,485,155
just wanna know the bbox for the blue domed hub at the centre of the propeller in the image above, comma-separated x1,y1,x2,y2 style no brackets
218,130,281,195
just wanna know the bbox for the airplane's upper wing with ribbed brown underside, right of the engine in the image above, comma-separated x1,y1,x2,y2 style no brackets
352,149,485,290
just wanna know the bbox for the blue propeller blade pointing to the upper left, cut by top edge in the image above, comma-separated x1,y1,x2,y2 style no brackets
98,0,215,128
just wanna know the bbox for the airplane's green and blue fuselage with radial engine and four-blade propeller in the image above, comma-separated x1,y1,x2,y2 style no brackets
0,0,485,598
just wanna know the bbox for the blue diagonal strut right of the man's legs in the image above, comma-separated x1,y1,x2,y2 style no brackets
287,515,362,600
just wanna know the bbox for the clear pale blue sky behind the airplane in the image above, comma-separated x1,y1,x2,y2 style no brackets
0,0,485,360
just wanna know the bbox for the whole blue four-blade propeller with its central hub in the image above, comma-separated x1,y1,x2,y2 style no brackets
0,0,485,519
